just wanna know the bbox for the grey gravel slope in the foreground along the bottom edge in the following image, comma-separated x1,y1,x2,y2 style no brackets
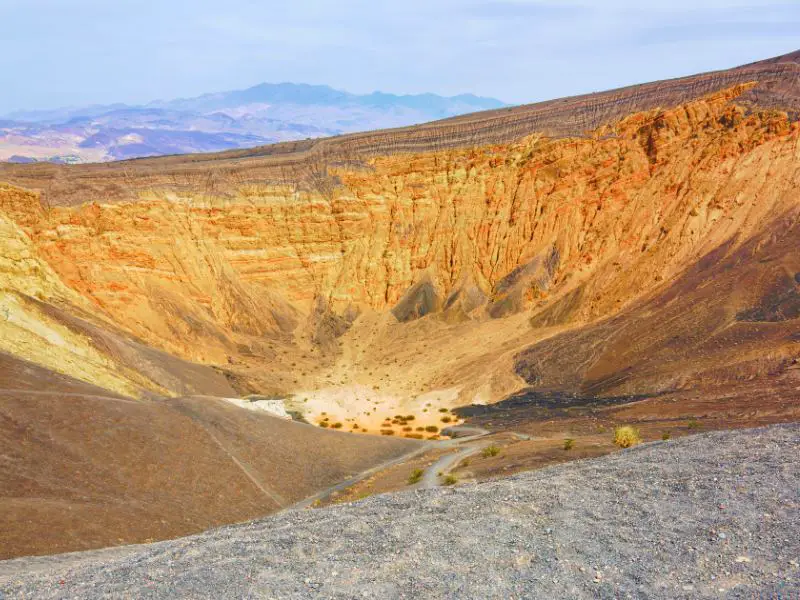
0,425,800,599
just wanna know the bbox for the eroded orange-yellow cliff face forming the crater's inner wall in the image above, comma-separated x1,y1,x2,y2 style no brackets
0,84,800,418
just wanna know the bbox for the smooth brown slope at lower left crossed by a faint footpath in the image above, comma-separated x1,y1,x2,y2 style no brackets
0,355,416,558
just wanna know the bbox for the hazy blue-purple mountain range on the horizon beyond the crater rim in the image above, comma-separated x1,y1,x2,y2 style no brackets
0,83,505,162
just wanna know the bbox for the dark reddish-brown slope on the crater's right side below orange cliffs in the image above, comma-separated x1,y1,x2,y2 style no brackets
515,209,800,399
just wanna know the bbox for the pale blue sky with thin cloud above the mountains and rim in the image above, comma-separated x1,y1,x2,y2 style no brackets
0,0,800,114
